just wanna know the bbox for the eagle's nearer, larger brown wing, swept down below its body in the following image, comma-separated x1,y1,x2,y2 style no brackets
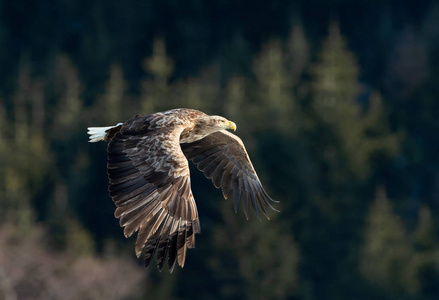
107,117,200,272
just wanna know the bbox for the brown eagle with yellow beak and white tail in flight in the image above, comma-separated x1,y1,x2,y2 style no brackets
88,108,277,272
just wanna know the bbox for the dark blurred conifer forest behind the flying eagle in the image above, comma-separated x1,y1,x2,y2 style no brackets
0,0,439,300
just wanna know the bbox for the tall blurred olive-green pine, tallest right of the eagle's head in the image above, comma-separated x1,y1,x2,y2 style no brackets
311,24,364,180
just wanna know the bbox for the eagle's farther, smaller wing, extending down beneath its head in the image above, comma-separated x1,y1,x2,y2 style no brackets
181,130,277,219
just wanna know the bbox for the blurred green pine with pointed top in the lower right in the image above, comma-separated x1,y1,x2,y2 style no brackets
360,188,419,296
